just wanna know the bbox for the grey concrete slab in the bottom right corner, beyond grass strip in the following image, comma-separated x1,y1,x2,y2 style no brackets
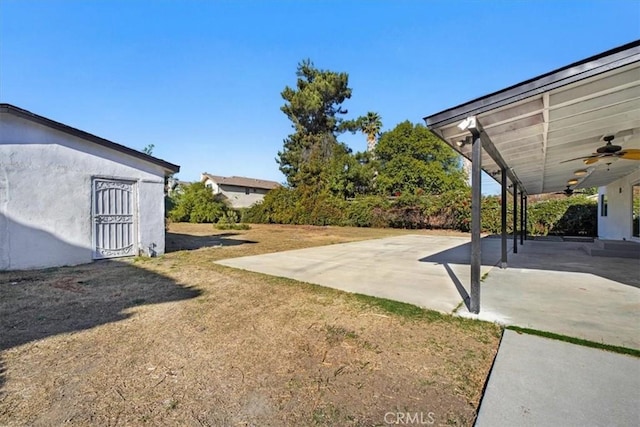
475,330,640,427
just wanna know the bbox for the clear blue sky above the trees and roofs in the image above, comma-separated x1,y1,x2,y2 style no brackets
0,0,640,193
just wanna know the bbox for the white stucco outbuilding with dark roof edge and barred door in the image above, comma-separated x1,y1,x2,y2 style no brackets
0,104,180,270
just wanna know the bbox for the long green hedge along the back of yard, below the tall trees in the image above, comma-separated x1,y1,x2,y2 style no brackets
242,188,597,236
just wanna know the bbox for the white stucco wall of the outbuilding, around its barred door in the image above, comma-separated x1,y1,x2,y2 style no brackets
0,113,169,270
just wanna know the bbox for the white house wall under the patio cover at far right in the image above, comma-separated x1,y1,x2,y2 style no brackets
598,169,640,240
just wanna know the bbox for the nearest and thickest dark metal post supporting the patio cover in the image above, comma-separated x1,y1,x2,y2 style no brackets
469,133,482,314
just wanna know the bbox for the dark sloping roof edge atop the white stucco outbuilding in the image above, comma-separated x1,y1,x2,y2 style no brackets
0,104,180,173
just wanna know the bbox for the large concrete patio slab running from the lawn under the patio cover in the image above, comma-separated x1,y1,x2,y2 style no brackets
219,235,640,348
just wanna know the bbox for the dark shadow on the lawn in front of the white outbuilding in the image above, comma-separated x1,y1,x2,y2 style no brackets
0,261,201,391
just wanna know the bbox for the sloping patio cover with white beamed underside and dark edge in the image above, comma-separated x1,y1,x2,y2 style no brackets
424,40,640,195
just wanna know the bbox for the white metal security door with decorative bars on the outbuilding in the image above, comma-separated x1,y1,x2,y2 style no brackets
92,178,137,259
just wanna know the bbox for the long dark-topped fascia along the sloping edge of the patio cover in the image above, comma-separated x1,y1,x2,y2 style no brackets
423,40,640,129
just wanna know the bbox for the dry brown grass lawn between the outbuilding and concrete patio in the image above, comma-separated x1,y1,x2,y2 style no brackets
0,224,501,426
